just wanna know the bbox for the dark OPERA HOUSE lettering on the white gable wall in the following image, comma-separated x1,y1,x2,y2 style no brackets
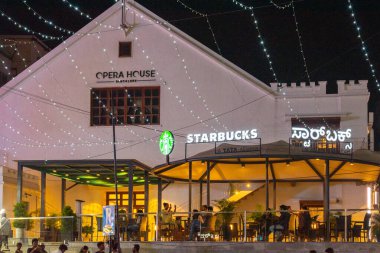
95,69,156,83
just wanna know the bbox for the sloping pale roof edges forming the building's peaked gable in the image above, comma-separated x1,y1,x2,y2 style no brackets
0,1,276,99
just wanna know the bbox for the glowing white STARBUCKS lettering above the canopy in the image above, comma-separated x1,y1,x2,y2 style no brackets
186,129,257,143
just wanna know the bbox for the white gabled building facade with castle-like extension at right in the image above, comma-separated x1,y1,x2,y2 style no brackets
0,2,370,224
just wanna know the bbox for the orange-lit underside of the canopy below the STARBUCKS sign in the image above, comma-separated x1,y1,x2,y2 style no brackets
154,158,380,182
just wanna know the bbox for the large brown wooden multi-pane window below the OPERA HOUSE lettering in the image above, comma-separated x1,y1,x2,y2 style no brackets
91,87,160,126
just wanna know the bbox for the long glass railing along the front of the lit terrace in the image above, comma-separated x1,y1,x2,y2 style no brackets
9,208,380,244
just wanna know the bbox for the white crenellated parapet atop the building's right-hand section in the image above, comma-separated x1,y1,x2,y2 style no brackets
270,80,368,96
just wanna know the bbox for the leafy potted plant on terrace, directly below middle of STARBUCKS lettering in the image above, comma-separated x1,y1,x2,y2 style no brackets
214,199,236,241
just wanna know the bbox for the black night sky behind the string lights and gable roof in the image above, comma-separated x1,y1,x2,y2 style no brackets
0,0,380,111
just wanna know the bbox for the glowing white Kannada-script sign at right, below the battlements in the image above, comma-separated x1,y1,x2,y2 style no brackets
292,127,352,150
